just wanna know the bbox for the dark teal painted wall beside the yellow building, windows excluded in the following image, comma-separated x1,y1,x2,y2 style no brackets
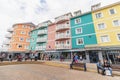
70,13,97,49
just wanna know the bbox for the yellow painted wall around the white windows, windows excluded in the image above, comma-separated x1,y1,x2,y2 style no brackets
92,4,120,46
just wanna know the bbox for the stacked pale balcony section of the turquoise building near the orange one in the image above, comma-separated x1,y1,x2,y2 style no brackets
35,20,51,51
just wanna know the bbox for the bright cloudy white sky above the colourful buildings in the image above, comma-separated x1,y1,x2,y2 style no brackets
0,0,120,45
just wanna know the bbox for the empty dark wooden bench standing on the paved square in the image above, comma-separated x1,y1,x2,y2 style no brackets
70,63,87,71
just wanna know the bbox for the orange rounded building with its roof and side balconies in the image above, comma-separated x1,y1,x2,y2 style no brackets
7,23,35,52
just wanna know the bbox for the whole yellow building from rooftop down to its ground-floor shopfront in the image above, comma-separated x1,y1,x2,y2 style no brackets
91,2,120,64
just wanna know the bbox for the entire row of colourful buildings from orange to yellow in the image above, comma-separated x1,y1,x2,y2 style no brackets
6,2,120,64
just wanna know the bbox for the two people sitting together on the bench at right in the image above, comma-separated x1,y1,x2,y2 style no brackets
97,59,112,75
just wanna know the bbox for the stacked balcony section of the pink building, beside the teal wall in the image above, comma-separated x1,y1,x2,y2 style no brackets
55,13,72,49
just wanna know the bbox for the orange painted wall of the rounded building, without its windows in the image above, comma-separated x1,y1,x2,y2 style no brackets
9,24,33,51
